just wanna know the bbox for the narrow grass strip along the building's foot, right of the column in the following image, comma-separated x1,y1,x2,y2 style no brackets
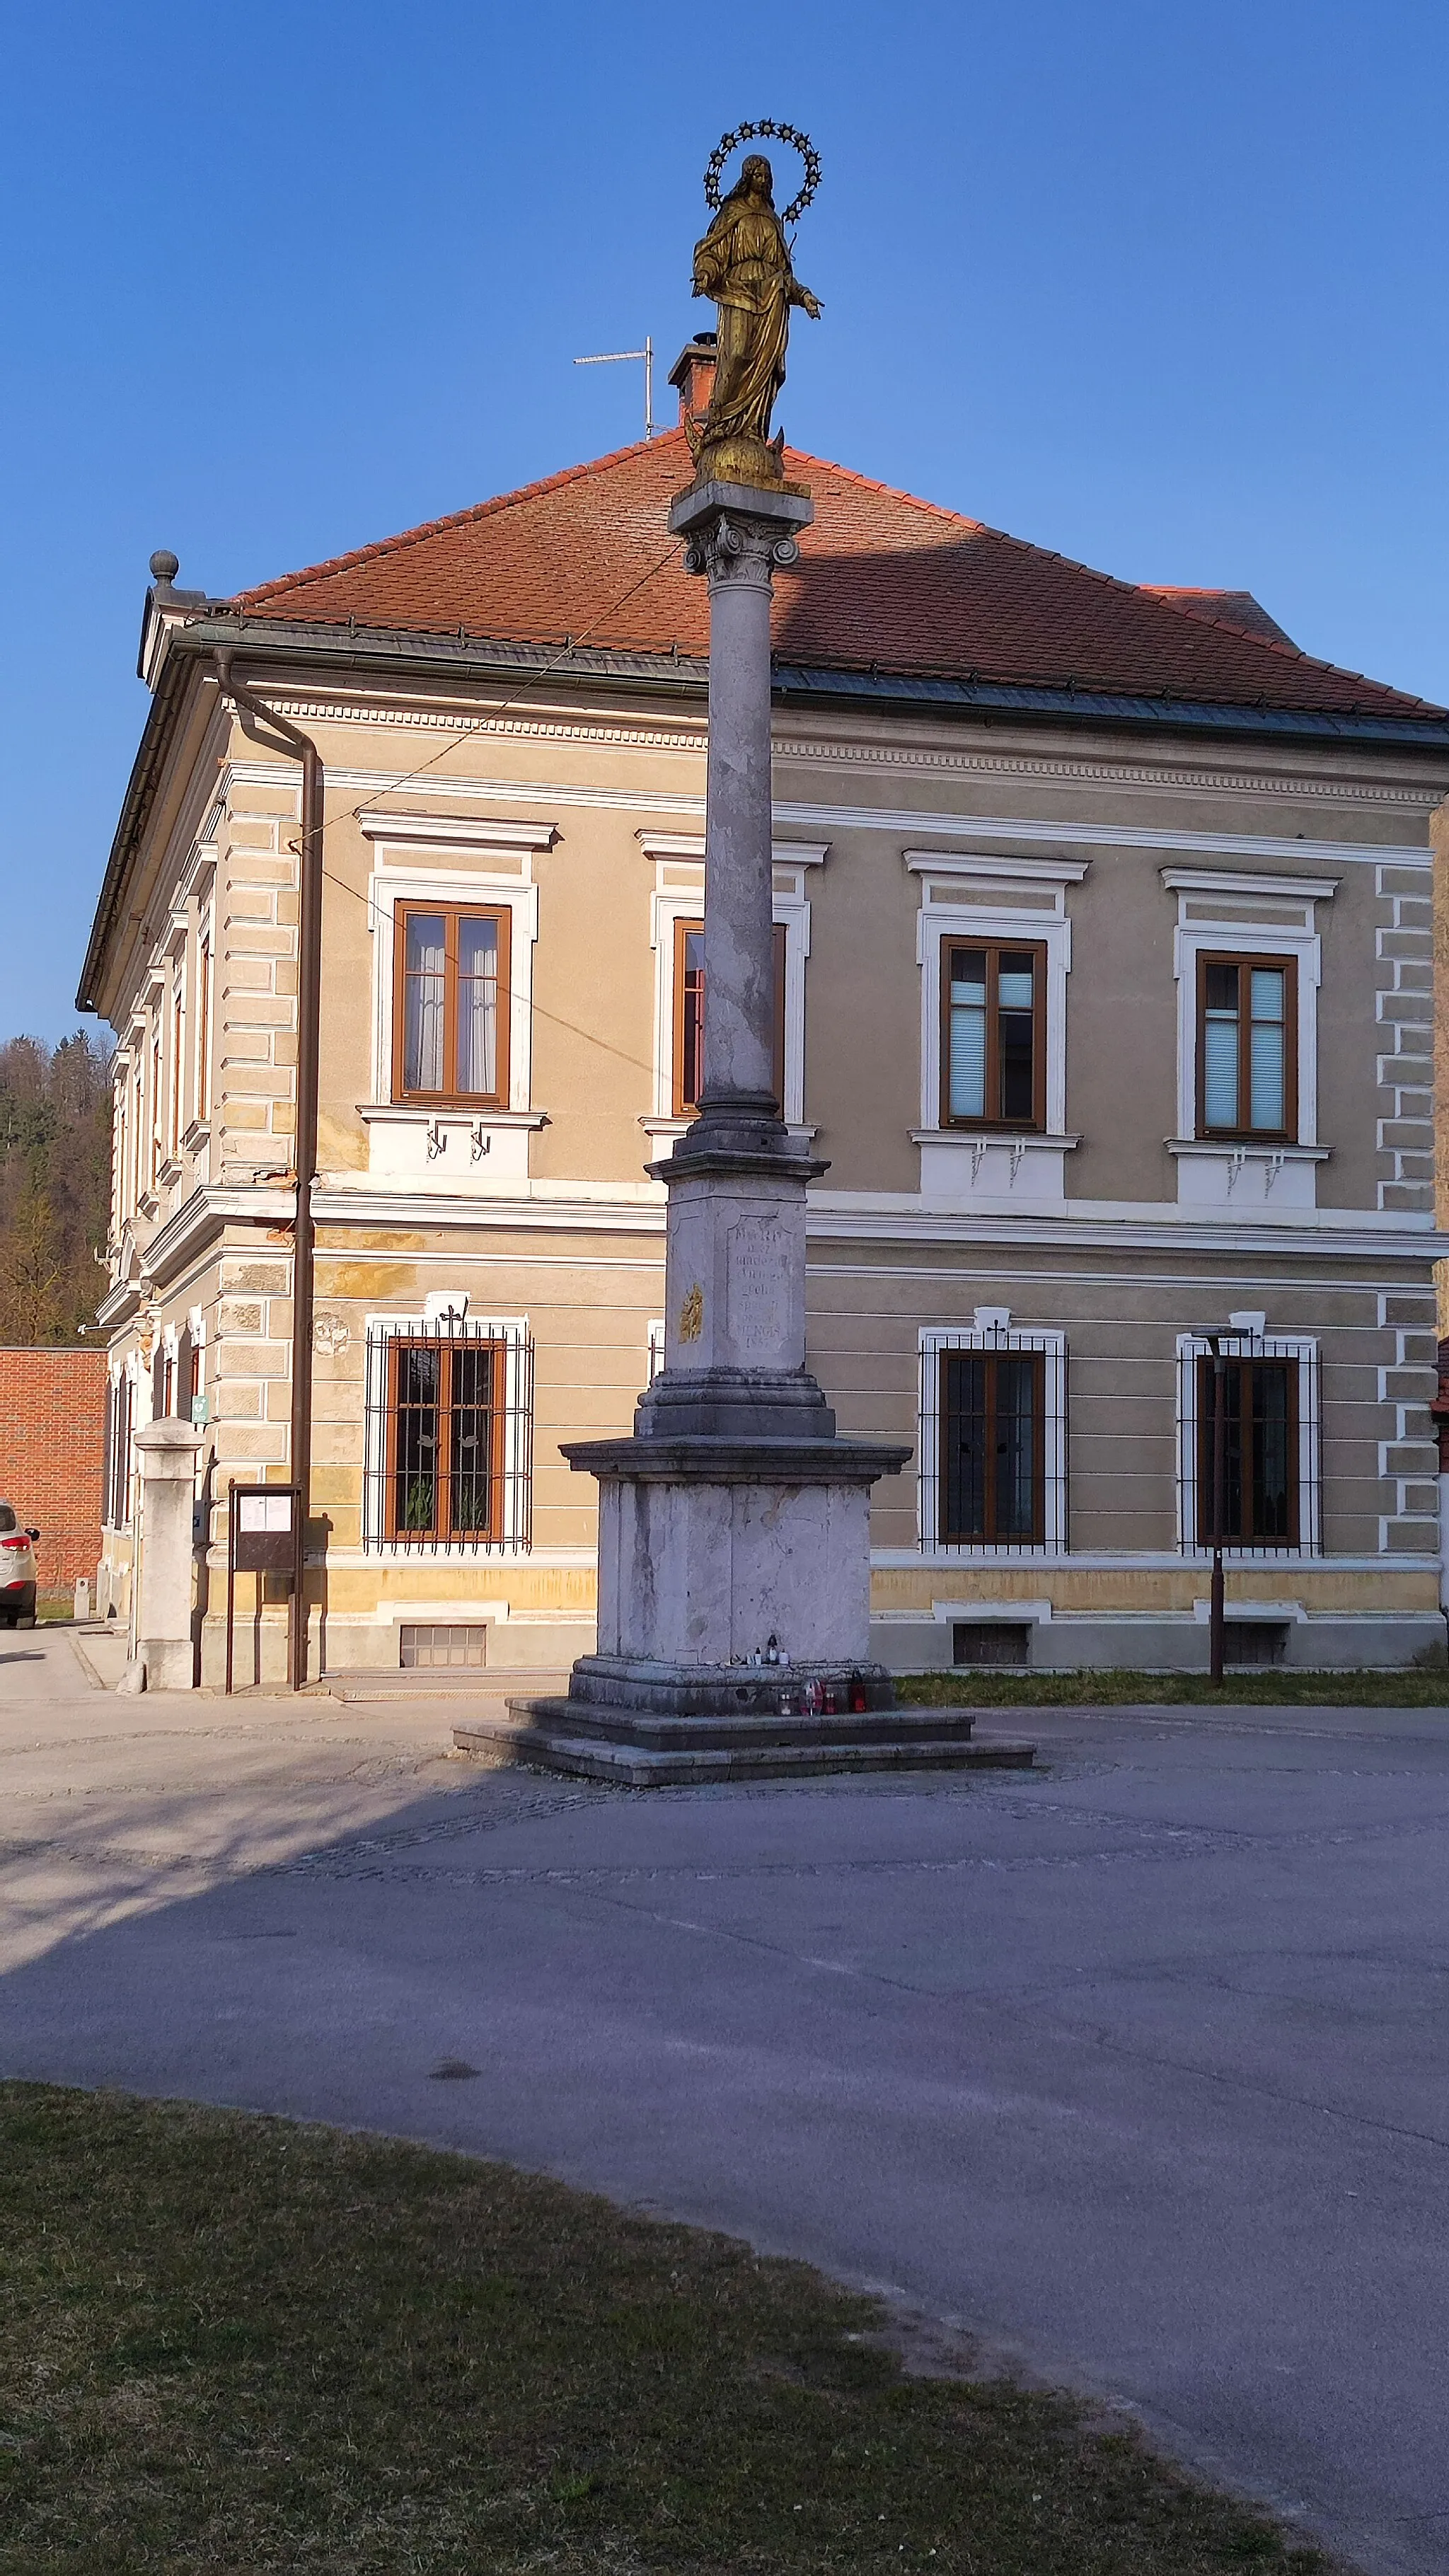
895,1664,1449,1711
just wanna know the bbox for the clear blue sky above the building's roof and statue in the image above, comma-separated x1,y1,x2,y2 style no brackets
0,0,1449,1038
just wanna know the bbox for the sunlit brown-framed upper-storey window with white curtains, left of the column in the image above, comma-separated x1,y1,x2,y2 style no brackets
392,904,511,1108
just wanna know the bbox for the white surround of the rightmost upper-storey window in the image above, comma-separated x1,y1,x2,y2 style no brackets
1160,868,1338,1157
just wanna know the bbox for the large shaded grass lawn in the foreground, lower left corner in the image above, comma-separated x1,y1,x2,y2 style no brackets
0,2084,1322,2576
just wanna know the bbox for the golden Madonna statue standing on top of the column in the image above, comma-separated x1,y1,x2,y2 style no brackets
691,152,820,485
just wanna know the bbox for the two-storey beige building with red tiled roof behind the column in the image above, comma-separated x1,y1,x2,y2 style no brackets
80,342,1449,1677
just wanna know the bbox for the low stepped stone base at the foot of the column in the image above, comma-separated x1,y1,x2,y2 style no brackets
454,1656,1037,1788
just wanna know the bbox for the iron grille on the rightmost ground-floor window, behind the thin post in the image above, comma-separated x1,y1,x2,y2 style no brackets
1178,1332,1322,1561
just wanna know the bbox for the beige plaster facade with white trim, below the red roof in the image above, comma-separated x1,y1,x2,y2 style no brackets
91,600,1449,1680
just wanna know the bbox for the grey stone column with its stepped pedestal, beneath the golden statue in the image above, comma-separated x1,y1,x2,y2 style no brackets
454,485,1032,1788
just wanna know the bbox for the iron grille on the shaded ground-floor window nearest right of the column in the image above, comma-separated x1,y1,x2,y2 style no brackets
916,1322,1068,1556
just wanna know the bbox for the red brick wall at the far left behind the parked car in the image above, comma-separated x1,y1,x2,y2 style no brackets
0,1350,105,1592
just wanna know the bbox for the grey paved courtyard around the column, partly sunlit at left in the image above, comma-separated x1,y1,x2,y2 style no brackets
0,1631,1449,2576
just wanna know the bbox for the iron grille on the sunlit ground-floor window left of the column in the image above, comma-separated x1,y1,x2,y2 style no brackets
364,1317,533,1556
